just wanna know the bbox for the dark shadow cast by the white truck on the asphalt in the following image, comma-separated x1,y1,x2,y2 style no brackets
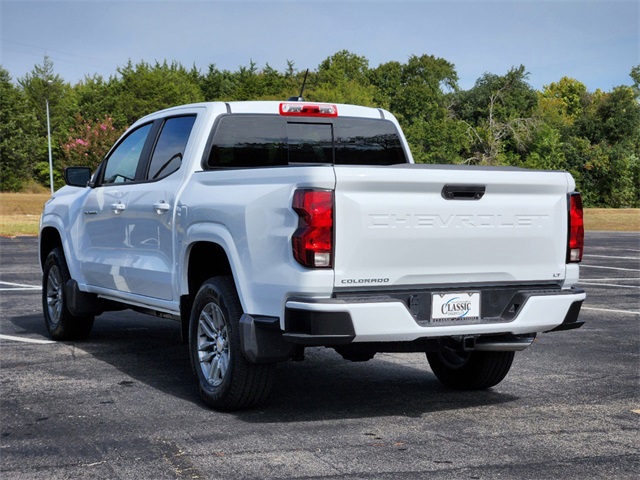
11,311,519,423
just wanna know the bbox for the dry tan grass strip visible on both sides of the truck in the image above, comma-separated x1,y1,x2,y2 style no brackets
0,193,640,237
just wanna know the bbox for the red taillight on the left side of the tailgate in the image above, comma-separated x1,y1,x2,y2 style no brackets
291,189,333,268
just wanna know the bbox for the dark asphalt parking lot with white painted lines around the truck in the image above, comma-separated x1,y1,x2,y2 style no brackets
0,232,640,479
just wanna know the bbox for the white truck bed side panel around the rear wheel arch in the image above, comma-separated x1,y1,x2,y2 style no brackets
179,167,335,317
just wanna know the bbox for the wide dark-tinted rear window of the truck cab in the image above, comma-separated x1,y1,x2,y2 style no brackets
205,114,407,168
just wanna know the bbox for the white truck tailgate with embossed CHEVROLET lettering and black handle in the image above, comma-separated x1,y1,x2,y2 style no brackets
334,164,575,289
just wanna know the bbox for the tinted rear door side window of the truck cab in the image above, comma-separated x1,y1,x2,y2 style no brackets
146,115,196,180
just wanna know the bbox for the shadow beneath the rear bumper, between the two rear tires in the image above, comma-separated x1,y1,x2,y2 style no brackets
239,348,519,423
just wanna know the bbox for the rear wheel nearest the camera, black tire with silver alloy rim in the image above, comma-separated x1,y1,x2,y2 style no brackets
189,276,276,410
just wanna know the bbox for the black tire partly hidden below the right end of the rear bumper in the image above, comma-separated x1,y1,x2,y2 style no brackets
427,350,515,390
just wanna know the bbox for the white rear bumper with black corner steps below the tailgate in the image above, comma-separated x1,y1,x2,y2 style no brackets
283,288,586,345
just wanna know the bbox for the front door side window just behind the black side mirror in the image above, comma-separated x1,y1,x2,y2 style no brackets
102,123,152,185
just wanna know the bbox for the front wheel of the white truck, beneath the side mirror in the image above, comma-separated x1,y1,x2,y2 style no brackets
42,248,95,340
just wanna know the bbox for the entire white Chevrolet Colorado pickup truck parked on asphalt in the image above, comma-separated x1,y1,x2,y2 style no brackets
39,101,585,410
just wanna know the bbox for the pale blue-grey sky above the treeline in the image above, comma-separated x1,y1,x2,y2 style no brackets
0,0,640,91
